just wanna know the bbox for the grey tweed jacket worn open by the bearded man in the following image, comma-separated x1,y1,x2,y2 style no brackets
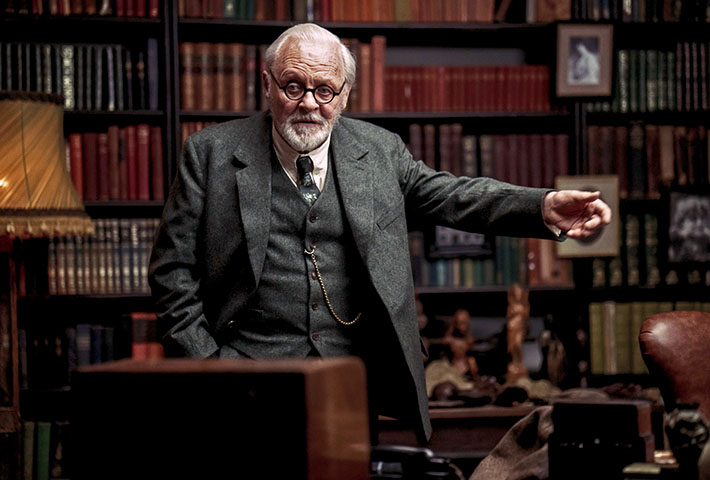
149,113,551,439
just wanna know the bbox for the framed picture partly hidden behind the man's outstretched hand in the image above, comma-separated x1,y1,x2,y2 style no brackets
555,175,619,258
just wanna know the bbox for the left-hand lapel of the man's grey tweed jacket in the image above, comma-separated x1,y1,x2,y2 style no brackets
234,114,272,285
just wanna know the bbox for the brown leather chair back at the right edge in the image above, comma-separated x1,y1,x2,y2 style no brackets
639,311,710,418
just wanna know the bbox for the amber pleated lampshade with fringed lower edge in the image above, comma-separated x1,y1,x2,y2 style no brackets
0,92,93,238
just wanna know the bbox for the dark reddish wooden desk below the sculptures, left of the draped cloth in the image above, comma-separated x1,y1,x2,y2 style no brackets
379,405,535,478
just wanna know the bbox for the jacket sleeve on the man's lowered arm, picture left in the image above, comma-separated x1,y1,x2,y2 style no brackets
148,138,218,357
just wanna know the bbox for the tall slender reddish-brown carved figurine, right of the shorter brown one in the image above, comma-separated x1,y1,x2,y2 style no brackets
505,283,530,384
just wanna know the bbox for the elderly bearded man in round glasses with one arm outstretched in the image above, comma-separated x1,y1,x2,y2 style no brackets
150,24,611,440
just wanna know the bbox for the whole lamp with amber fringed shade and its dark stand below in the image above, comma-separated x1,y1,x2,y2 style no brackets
0,91,93,472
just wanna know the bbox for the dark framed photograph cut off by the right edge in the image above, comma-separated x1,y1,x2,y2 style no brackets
668,191,710,264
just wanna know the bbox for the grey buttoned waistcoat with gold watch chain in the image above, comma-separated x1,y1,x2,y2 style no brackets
230,152,367,358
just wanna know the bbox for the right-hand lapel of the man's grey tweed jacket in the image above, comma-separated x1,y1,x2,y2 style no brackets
330,122,375,264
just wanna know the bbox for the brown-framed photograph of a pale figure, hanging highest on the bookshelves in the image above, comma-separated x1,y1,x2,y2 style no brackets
555,24,614,97
